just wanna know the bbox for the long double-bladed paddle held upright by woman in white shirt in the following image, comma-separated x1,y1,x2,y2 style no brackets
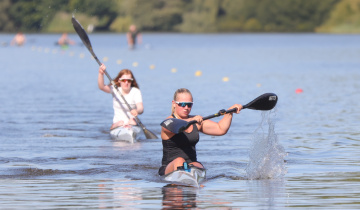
71,17,158,139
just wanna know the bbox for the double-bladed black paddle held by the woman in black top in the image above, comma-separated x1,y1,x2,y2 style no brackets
160,93,278,134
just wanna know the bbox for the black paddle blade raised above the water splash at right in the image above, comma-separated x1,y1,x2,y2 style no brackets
243,93,278,111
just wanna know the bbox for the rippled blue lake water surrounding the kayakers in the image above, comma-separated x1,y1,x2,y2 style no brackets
0,34,360,209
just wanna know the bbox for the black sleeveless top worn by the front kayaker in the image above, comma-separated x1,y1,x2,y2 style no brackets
159,118,199,175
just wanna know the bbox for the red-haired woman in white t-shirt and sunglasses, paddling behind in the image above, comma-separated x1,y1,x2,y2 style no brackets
98,64,144,129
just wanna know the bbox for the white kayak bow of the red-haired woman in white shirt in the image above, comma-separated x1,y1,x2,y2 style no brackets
110,125,141,143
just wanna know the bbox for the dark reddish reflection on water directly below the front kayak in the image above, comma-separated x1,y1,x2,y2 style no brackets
162,184,198,209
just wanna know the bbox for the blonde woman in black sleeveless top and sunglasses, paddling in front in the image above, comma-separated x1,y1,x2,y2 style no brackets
159,88,242,176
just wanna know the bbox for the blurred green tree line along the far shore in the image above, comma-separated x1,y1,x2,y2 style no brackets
0,0,360,33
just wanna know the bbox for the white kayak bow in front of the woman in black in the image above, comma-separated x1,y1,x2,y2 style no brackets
164,166,206,187
